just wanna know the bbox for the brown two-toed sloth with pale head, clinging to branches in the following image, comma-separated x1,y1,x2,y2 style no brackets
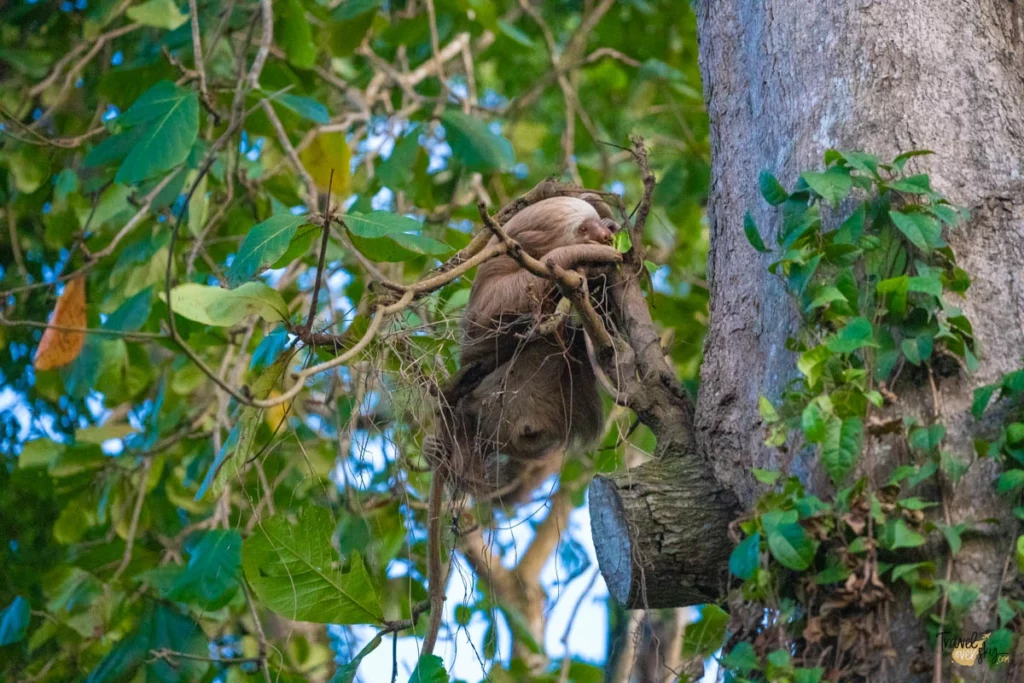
427,196,622,505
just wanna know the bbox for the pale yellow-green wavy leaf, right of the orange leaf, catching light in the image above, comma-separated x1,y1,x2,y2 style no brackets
166,283,288,328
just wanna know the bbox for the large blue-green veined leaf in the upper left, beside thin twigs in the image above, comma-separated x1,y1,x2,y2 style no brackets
114,81,199,184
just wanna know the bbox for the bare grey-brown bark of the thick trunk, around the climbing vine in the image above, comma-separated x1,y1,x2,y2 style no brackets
692,0,1024,681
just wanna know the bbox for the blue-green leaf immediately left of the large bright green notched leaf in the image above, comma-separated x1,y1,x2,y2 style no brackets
167,529,242,611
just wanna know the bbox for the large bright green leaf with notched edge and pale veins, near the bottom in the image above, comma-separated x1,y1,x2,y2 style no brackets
242,508,384,624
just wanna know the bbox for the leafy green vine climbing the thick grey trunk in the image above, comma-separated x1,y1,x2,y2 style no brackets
708,150,1024,683
